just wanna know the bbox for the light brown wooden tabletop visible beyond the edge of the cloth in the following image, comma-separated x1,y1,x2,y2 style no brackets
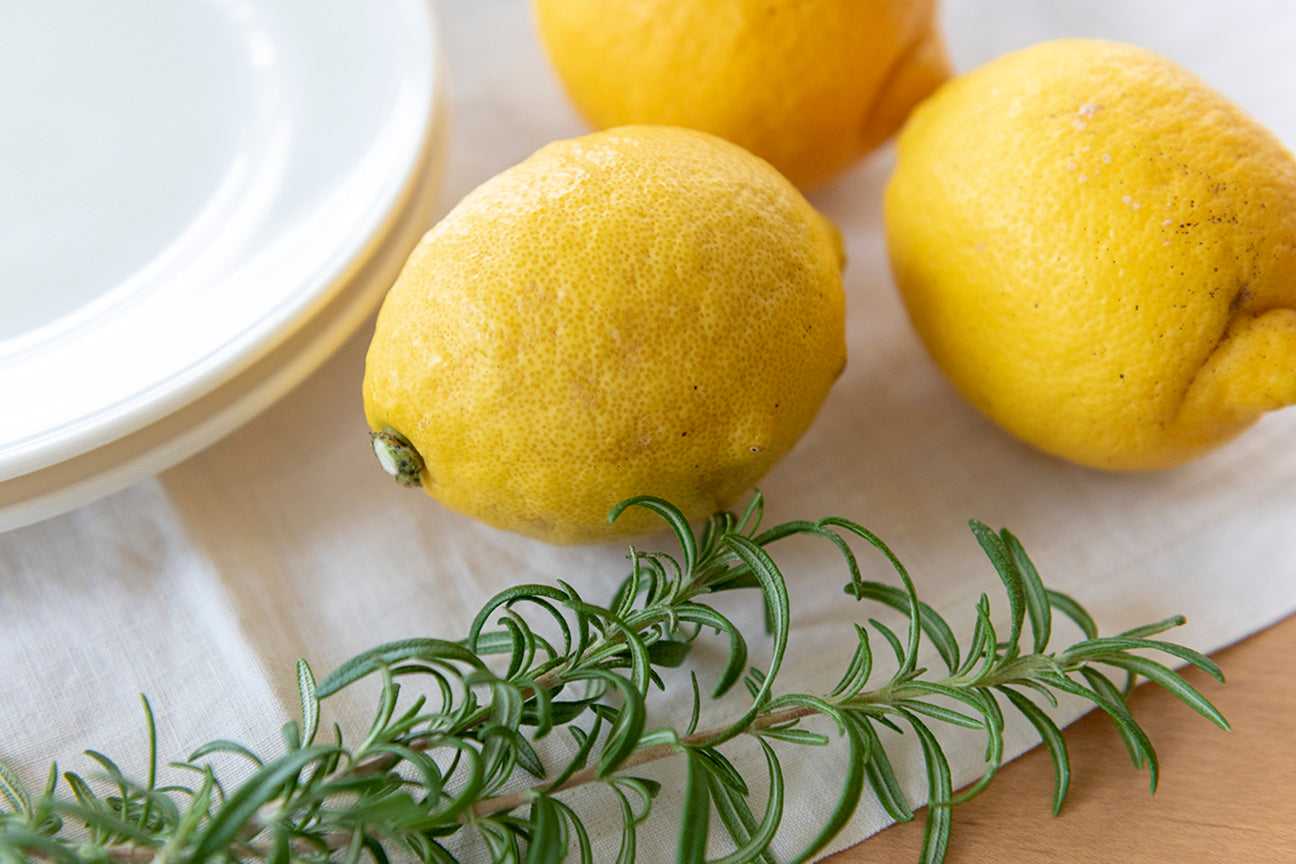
827,617,1296,864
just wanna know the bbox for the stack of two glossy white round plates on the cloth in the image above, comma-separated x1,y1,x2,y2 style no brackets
0,0,445,530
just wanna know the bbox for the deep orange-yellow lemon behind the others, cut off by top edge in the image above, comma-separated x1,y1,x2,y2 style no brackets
533,0,949,188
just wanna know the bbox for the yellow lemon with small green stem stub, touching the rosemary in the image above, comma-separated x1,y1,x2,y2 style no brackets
364,127,846,544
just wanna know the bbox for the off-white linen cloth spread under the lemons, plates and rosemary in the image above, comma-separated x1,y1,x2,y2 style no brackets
0,0,1296,863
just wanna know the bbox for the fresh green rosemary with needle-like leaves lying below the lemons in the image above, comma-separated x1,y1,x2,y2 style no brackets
0,494,1227,864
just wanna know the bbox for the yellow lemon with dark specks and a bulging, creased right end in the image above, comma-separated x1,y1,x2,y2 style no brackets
885,40,1296,470
